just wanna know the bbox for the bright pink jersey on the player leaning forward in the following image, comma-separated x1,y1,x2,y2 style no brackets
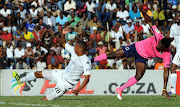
135,25,171,67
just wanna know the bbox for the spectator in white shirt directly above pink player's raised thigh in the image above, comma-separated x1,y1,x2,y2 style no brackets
111,27,124,50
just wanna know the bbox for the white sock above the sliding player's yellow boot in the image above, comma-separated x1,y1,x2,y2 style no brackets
19,72,36,83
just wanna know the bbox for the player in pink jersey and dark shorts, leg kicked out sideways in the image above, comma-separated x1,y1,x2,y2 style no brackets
92,3,171,100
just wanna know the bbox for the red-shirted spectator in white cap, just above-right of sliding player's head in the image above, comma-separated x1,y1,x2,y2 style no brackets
90,27,102,43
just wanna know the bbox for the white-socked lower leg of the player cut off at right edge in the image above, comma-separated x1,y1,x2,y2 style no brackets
169,64,177,97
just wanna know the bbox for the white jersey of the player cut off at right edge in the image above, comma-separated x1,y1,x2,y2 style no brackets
170,24,180,51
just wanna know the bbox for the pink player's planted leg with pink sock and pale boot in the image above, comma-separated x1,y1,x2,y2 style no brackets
115,62,146,100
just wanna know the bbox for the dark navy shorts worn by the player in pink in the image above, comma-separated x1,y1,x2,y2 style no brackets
121,44,148,64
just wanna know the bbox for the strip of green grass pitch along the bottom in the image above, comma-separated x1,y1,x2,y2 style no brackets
0,96,180,107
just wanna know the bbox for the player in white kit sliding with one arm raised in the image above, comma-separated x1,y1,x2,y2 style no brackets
13,28,91,101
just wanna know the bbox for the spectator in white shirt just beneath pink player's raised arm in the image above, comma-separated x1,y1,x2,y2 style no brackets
141,18,150,39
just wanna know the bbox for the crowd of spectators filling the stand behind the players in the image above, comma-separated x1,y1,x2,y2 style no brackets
0,0,180,69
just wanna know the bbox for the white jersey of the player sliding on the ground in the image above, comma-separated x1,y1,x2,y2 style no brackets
63,43,91,84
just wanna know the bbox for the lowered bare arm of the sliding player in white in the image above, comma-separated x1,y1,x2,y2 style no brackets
73,75,90,95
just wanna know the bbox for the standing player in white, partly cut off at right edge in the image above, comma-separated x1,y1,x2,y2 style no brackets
169,12,180,96
